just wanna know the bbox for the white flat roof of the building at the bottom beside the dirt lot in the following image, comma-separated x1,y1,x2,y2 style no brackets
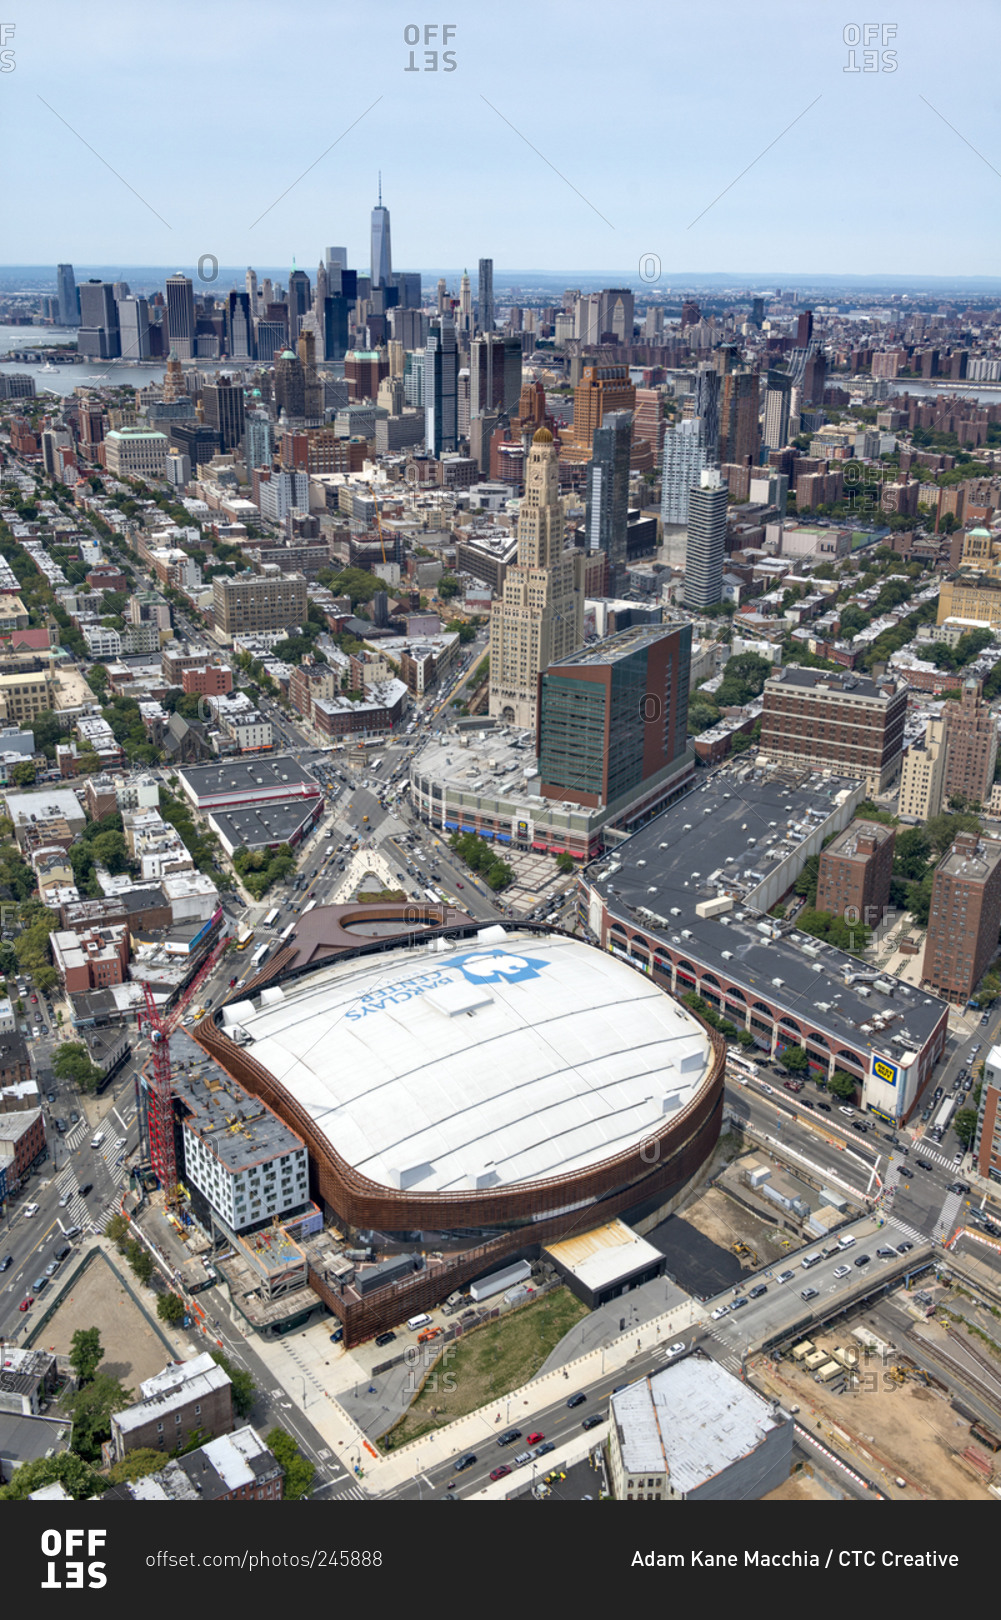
611,1356,789,1492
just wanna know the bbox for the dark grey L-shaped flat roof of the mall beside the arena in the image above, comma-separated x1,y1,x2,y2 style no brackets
586,765,946,1056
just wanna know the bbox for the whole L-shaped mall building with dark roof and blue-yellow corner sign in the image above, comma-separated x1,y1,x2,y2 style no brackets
580,766,949,1124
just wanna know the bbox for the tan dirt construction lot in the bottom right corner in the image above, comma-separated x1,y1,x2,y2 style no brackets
752,1347,990,1502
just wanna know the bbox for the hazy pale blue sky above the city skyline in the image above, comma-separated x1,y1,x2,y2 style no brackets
0,0,1001,280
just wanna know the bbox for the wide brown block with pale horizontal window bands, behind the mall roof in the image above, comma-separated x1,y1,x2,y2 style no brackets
758,664,907,797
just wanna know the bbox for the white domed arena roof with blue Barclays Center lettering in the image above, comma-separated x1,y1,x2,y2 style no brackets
224,927,711,1192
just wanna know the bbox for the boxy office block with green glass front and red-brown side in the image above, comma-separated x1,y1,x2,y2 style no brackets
536,624,692,808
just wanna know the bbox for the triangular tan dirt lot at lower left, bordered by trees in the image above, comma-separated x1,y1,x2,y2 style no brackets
28,1252,185,1390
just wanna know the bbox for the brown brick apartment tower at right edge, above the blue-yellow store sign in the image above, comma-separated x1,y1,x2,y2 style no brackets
922,833,1001,1006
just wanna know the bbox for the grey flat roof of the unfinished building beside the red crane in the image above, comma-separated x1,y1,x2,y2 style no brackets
170,1029,303,1175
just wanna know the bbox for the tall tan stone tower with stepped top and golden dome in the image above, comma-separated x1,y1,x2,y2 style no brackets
489,428,583,726
